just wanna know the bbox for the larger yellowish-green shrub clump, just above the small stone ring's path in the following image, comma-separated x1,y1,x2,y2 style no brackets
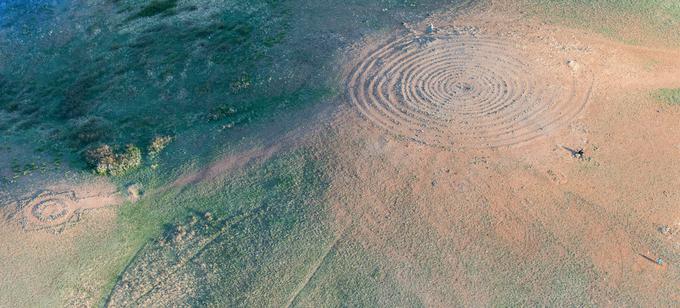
85,144,142,176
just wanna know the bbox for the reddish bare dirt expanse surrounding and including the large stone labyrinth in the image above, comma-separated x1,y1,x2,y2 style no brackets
318,2,680,306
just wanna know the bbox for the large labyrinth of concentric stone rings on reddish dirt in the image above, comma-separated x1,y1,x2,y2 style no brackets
347,35,592,149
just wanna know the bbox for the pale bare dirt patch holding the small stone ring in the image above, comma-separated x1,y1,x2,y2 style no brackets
0,181,128,306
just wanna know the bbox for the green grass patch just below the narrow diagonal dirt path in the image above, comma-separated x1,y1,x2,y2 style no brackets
100,151,329,305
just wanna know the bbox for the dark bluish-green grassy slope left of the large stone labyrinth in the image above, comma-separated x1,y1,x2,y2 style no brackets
0,0,460,182
